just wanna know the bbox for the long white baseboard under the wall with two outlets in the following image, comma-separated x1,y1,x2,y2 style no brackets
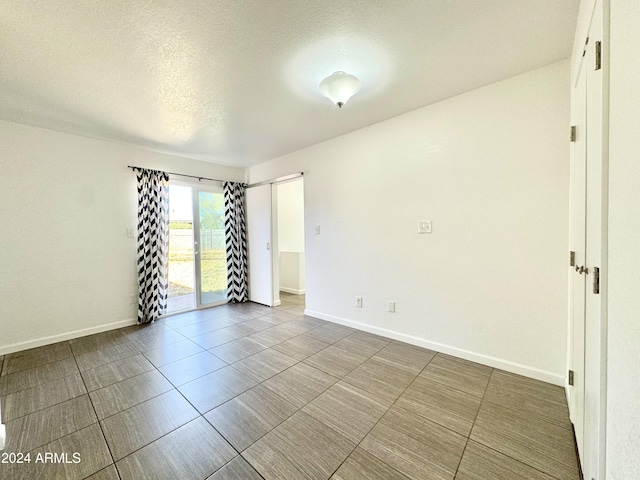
304,309,565,387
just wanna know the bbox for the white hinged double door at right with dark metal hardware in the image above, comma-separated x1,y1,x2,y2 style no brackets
570,1,606,480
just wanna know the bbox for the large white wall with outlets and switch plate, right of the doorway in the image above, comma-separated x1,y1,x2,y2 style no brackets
249,61,570,385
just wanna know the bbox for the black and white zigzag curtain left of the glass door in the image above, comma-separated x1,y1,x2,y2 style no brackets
134,168,169,323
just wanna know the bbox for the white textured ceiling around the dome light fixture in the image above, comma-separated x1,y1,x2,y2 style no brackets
0,0,579,167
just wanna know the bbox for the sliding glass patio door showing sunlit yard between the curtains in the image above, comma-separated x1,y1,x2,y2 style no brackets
167,185,227,313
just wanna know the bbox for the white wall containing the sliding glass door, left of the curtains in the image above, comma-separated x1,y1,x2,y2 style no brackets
0,121,244,354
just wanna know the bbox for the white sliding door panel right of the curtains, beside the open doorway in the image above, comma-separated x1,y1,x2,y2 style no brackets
245,185,273,307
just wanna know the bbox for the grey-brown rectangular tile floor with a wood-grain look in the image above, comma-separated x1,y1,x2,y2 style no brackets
0,295,579,480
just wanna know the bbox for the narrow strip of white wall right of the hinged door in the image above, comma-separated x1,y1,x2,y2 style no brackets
607,0,640,480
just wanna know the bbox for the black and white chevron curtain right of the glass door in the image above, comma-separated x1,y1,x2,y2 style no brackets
222,182,249,303
